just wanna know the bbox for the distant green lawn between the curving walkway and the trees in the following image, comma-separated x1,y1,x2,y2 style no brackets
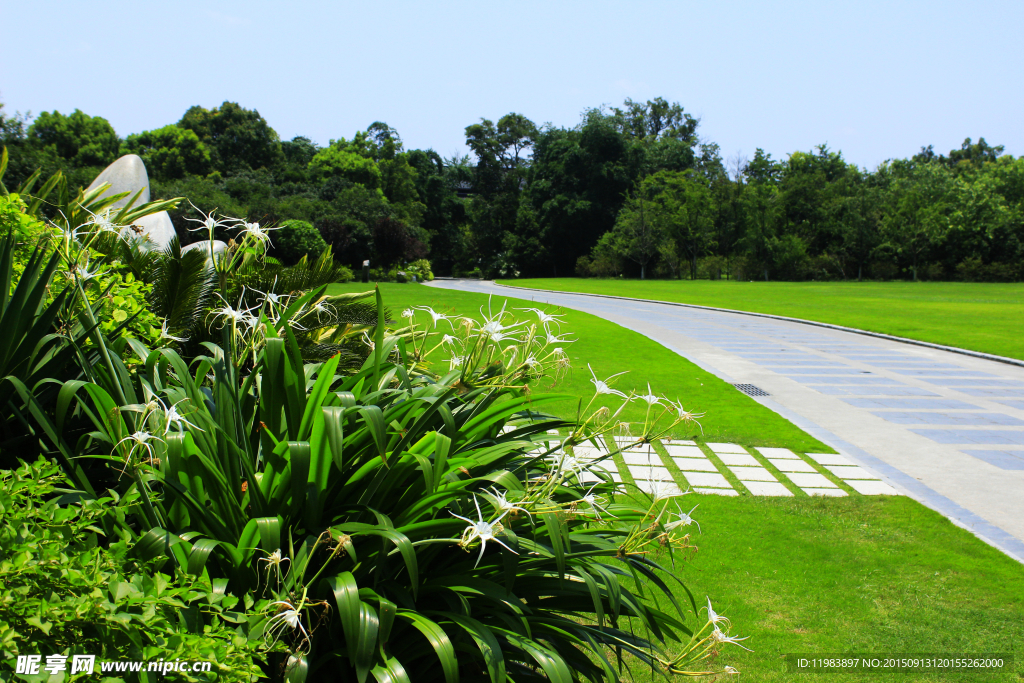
501,278,1024,359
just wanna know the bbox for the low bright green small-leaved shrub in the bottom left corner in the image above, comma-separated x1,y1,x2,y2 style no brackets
0,459,262,681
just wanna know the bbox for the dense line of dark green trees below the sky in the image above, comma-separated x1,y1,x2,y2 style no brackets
0,98,1024,282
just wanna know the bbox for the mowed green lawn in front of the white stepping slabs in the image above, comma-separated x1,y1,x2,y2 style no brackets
622,495,1024,682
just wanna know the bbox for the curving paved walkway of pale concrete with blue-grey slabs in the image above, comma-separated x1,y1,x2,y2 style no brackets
432,281,1024,561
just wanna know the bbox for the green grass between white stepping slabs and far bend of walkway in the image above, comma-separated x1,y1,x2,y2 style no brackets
330,283,833,453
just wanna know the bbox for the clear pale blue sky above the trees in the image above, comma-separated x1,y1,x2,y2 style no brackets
0,0,1024,169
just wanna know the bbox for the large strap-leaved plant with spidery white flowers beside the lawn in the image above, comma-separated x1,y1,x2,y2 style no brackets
24,292,745,682
